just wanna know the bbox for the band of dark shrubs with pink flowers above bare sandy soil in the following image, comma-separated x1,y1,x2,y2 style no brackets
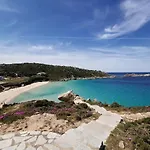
0,100,99,124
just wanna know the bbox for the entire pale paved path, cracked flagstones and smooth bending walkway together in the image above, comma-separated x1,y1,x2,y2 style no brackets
0,99,121,150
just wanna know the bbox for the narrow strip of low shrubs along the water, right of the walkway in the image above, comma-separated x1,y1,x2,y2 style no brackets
85,99,150,113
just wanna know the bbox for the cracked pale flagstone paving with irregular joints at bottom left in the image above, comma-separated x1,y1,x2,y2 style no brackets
0,131,61,150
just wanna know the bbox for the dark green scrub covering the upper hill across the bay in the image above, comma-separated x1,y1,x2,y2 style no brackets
0,63,106,80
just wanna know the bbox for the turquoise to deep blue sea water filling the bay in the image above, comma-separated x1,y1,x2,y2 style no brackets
13,72,150,107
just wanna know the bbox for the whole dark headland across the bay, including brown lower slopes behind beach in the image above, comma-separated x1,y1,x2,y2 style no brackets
0,63,110,91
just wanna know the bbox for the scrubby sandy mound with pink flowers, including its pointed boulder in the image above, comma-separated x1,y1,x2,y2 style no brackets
0,91,101,134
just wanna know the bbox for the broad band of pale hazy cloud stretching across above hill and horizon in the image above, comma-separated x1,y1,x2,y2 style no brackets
0,44,150,72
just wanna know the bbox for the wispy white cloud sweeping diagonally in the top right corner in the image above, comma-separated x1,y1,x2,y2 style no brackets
98,0,150,39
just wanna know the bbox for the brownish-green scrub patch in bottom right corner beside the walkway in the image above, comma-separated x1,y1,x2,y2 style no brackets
106,118,150,150
